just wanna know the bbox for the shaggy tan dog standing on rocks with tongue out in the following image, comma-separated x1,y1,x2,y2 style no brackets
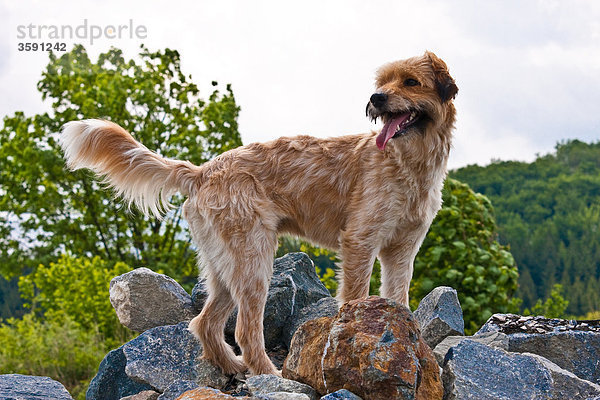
60,52,458,374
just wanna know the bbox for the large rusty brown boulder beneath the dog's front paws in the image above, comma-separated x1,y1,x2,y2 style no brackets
283,296,442,400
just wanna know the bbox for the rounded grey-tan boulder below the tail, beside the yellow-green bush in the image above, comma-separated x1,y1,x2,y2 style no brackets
110,268,195,332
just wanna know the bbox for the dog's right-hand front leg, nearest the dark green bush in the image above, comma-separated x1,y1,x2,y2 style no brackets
379,226,428,307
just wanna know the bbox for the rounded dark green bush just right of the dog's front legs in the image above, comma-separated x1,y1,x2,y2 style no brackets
410,178,518,332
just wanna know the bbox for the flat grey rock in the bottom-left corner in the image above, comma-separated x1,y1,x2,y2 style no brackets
0,374,73,400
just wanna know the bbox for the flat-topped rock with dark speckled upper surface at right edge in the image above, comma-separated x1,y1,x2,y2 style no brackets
478,314,600,384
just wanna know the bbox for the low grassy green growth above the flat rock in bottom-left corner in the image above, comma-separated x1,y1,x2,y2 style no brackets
0,314,110,398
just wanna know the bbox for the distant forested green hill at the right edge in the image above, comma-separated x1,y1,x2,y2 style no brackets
450,140,600,316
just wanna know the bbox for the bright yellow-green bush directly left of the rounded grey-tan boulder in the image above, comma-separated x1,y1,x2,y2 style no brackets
19,255,131,346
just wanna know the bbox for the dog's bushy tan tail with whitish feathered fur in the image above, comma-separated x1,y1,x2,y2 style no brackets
59,119,200,217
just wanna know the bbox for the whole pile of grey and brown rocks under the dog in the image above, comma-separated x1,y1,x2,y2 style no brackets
0,253,600,400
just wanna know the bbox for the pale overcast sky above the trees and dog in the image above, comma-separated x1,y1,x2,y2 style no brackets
0,0,600,167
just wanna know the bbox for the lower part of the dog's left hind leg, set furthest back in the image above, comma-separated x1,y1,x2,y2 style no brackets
188,273,246,374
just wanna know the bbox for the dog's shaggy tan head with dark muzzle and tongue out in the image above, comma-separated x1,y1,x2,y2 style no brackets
366,52,458,150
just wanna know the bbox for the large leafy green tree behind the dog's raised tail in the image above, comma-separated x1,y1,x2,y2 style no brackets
0,46,241,286
